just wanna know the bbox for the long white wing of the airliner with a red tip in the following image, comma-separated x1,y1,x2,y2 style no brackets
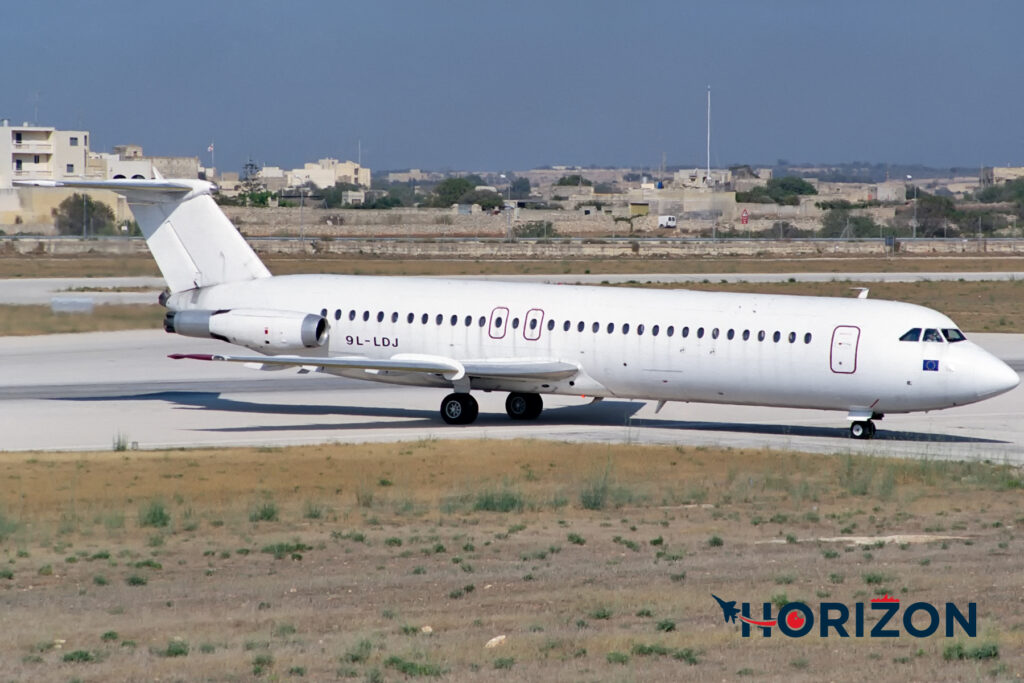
169,353,580,380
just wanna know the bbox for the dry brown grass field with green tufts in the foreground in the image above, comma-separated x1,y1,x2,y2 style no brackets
0,440,1024,681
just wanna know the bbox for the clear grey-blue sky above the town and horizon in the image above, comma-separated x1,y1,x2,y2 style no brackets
0,0,1024,176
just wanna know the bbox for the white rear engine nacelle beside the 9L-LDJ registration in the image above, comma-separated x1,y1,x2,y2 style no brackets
164,308,330,352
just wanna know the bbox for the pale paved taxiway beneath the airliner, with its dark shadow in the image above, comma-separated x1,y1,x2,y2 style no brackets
0,331,1024,464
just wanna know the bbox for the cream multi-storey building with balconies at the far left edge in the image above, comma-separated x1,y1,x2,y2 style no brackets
0,119,89,188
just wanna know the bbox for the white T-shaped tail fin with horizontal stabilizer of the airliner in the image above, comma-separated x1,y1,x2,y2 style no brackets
18,178,270,294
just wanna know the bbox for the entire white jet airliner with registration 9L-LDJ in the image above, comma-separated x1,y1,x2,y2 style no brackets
18,177,1020,438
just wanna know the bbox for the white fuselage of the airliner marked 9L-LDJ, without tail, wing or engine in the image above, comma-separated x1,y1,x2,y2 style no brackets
168,274,1018,418
